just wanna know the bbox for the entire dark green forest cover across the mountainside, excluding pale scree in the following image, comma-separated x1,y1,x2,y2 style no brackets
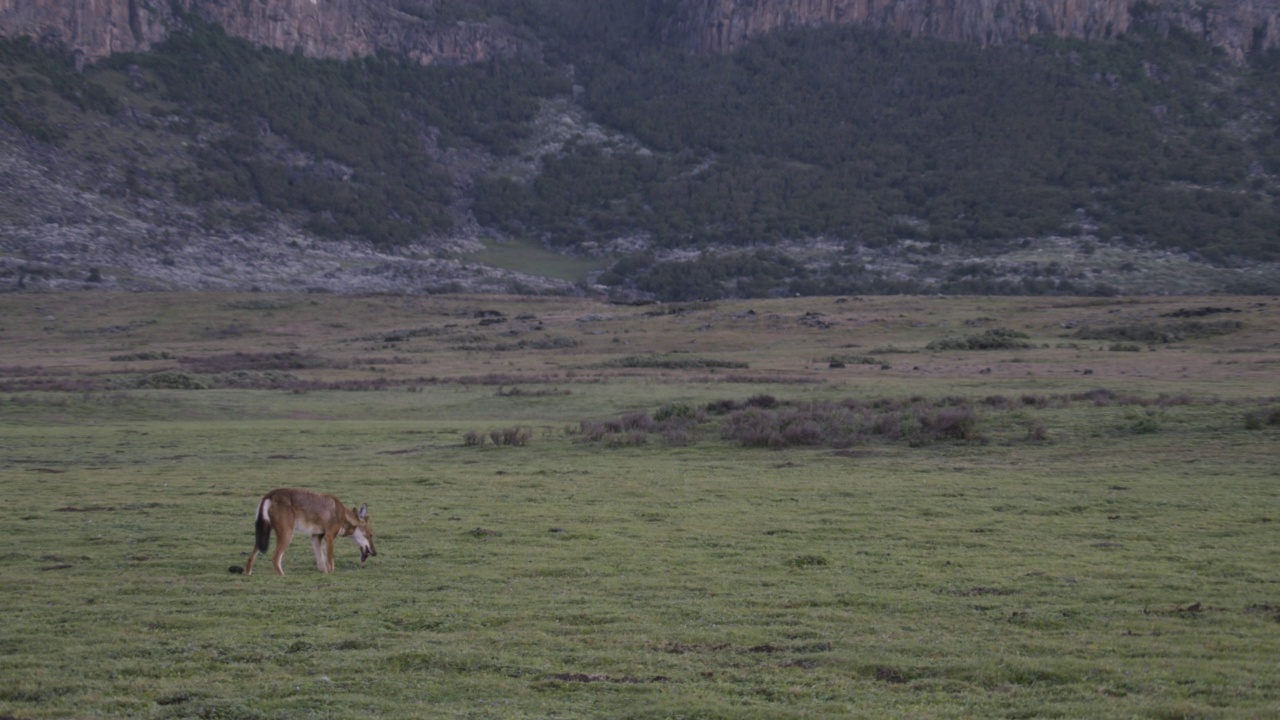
0,0,1280,300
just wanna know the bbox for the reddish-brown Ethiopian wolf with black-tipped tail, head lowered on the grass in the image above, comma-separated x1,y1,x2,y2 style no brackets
244,488,378,575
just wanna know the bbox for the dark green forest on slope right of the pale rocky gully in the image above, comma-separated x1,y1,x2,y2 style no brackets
480,19,1280,260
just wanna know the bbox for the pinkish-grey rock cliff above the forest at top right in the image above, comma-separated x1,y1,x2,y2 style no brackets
653,0,1280,59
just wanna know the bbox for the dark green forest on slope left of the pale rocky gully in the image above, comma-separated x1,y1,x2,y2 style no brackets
133,23,566,245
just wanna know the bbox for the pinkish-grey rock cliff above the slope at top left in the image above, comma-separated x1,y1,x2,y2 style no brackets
0,0,538,64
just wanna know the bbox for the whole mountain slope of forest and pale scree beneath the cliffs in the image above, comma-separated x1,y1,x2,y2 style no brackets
0,0,1280,294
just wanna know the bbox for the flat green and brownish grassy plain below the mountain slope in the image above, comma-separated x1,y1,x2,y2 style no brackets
0,288,1280,719
